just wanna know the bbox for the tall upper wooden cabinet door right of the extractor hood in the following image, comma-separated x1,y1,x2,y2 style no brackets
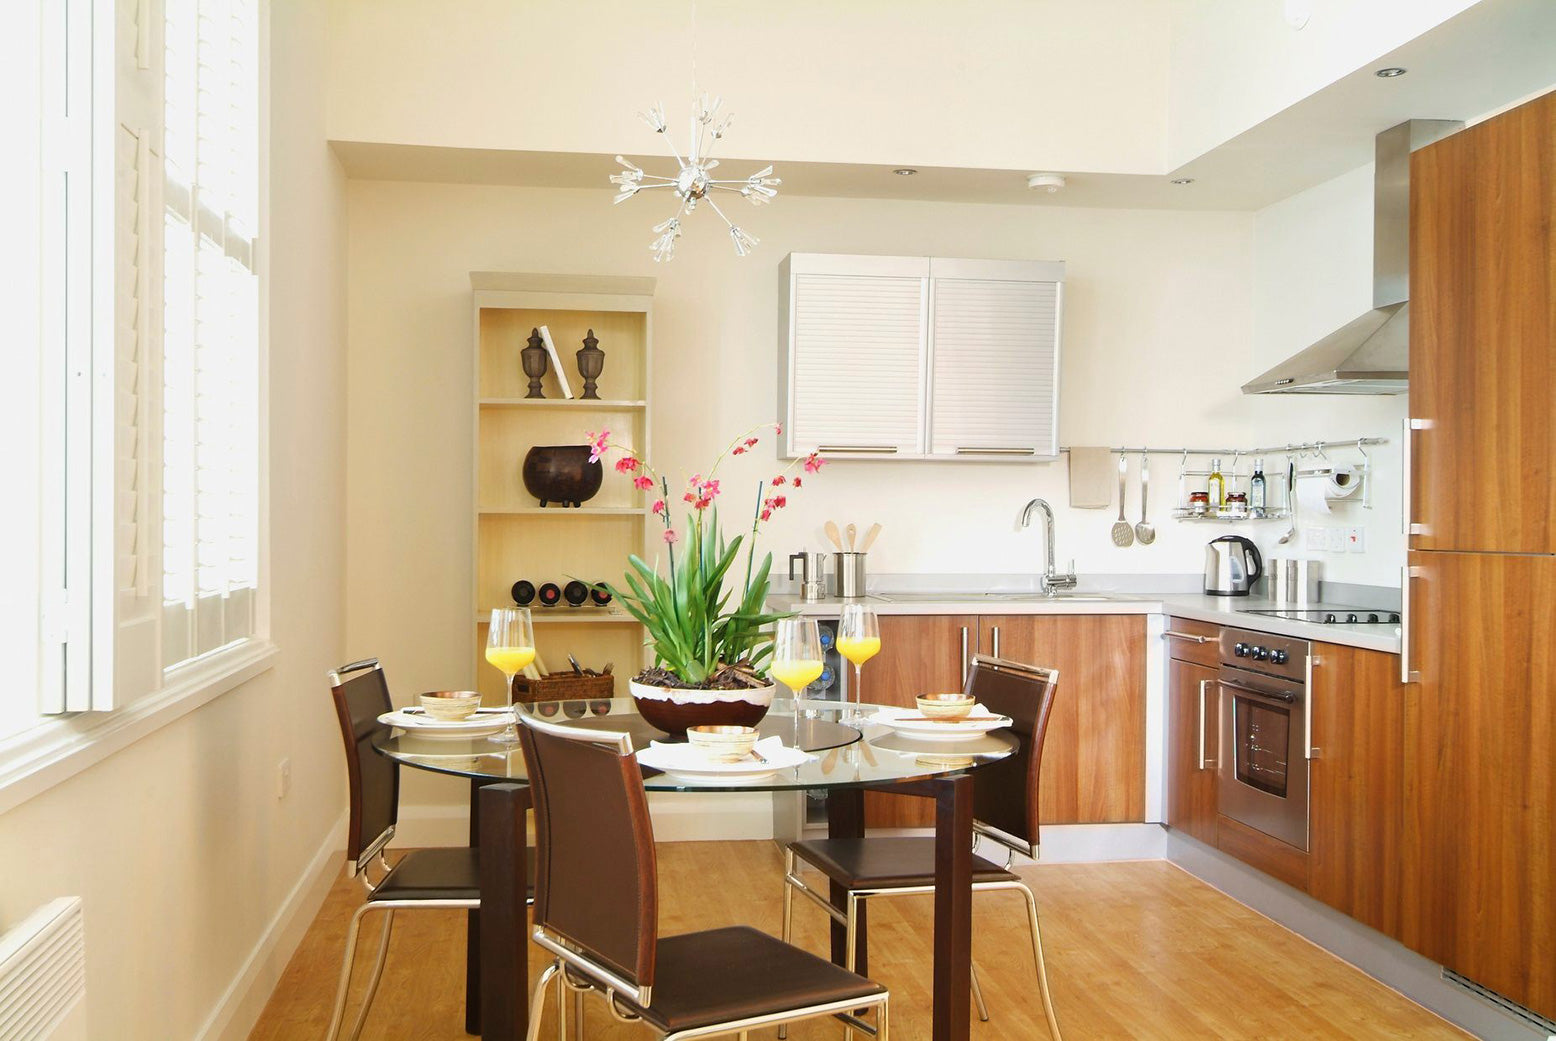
1408,92,1556,552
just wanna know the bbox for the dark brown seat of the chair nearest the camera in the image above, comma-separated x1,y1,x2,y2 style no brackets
622,926,885,1033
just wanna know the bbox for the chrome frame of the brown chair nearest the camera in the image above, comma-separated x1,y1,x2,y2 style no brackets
520,716,892,1041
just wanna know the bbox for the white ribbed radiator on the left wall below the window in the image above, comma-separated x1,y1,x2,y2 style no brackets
0,896,87,1041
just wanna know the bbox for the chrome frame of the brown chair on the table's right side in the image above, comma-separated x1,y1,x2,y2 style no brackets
778,655,1063,1041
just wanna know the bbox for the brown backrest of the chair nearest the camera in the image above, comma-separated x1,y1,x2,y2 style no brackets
518,714,658,999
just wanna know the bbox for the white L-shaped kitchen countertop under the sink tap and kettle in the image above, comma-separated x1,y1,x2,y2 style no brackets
769,591,1399,654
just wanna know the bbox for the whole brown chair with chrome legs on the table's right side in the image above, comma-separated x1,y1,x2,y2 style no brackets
780,655,1060,1041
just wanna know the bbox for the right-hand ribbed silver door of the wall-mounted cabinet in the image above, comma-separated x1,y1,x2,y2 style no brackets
930,277,1060,456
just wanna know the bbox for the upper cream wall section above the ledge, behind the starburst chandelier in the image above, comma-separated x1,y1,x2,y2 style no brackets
330,0,1170,173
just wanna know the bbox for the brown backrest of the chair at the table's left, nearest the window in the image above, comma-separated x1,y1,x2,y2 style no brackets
330,658,400,870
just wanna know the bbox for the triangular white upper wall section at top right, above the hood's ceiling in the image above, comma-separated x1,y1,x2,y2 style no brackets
1167,0,1480,170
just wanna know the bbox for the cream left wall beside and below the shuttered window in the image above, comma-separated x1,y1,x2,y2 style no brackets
0,0,345,1041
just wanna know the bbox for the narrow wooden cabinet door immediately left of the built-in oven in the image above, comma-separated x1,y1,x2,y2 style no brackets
1170,658,1220,846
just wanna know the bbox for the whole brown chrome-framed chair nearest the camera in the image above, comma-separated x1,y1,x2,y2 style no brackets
520,716,887,1041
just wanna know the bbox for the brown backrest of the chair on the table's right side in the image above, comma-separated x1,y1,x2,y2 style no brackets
966,655,1060,856
